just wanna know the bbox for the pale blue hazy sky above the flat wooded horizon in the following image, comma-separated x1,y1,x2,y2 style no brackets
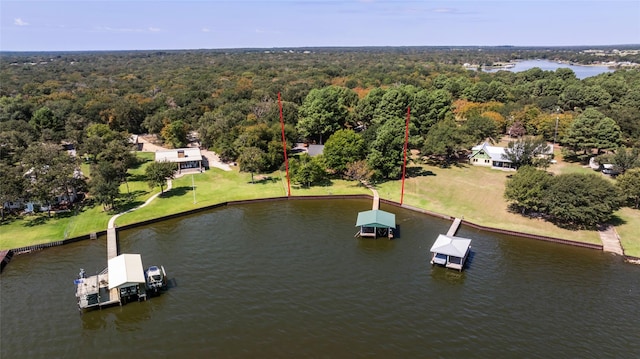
0,0,640,51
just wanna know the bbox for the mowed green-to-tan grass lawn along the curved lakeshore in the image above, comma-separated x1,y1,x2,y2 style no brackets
0,153,640,256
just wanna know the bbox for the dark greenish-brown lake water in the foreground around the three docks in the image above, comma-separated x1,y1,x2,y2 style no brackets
0,200,640,359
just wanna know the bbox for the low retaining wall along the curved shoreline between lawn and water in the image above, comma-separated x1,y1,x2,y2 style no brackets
0,194,640,272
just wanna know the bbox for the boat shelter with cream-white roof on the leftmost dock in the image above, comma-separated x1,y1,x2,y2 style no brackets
108,254,146,299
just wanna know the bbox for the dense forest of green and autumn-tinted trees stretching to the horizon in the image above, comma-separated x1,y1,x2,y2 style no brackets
0,47,640,224
